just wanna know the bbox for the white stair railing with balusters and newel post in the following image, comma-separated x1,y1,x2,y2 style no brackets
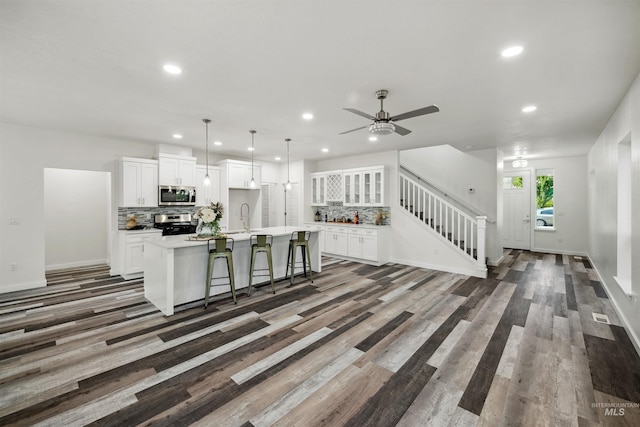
399,172,487,270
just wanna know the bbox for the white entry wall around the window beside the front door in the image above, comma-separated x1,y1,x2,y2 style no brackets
504,156,592,255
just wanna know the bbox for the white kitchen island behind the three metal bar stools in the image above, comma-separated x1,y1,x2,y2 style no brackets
144,226,321,316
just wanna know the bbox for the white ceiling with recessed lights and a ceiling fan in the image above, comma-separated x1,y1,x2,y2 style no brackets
0,0,640,164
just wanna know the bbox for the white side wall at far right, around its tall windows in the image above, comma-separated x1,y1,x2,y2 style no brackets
588,71,640,351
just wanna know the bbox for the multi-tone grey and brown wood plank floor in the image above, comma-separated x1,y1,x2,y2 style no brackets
0,251,640,427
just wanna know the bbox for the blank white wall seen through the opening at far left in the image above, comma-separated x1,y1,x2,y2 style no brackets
44,168,111,270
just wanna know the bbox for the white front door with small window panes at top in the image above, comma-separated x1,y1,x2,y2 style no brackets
502,170,531,250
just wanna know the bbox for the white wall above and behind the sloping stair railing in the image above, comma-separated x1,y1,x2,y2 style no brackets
400,145,502,264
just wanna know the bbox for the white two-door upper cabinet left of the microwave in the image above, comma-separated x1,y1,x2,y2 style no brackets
119,157,158,207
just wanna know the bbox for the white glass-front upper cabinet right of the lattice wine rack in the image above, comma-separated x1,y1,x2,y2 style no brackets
342,166,388,206
